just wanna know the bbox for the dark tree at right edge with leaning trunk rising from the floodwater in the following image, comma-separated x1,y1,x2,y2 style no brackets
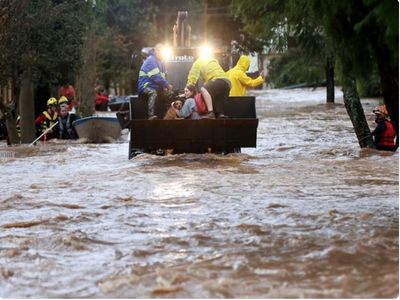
314,0,399,147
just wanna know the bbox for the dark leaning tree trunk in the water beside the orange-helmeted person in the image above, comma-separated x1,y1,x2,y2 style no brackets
343,79,375,148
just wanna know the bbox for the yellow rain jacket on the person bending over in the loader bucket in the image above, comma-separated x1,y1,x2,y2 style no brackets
187,58,228,85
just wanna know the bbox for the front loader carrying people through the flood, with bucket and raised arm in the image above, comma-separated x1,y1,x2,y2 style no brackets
126,12,258,159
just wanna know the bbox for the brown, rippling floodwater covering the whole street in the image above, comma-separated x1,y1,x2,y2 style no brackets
0,88,399,298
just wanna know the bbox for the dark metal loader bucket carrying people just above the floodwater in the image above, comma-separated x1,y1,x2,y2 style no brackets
128,97,258,159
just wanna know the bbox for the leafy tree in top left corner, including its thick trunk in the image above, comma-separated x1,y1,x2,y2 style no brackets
0,0,91,143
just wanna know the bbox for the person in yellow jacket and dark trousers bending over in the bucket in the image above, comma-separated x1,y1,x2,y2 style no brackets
186,52,231,119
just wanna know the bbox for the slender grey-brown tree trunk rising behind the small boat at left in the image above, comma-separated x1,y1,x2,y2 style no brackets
76,25,96,117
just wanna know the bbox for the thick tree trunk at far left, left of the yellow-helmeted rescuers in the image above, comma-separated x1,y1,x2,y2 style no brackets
19,70,35,144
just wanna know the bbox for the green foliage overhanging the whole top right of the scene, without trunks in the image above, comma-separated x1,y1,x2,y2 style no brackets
232,0,399,98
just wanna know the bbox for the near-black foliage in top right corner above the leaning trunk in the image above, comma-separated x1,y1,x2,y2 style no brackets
314,0,399,84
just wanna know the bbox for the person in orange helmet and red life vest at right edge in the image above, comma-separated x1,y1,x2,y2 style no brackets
371,105,396,151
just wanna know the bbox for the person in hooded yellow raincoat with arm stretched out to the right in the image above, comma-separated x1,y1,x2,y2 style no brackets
226,55,264,96
